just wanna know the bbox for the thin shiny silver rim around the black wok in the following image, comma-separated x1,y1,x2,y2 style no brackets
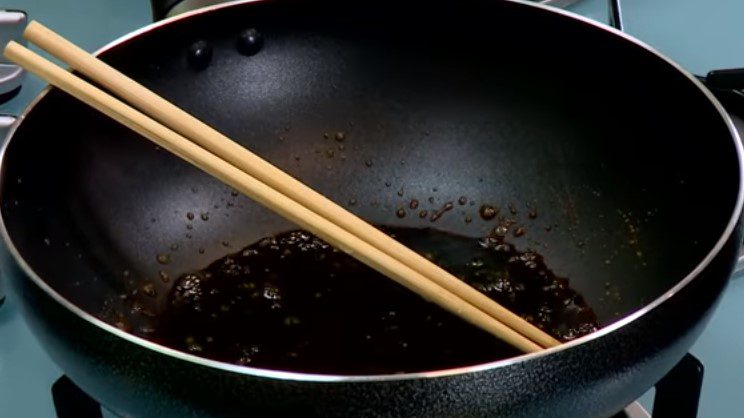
0,0,744,383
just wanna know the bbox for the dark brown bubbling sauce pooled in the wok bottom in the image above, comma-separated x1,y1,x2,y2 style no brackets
147,228,598,374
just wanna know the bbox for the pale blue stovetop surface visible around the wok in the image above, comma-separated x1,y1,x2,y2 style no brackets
0,0,744,418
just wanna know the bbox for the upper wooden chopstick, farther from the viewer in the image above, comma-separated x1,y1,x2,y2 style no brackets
24,21,560,347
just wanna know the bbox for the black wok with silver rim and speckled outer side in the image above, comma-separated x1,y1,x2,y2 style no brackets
0,0,742,417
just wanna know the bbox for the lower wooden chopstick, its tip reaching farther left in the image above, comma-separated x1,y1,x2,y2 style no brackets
5,42,542,352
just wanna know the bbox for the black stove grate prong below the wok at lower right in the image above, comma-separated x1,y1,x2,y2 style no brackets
651,353,704,418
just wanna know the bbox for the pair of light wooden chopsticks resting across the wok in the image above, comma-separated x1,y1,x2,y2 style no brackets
5,22,560,352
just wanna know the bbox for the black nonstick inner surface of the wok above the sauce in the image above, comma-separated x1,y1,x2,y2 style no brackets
2,0,737,366
